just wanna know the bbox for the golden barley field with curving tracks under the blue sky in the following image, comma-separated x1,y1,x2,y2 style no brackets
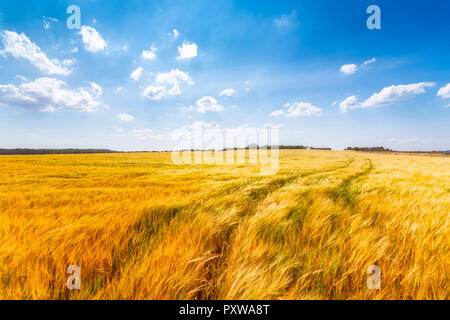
0,150,450,299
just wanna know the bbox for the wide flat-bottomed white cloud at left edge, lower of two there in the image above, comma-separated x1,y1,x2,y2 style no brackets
0,78,105,112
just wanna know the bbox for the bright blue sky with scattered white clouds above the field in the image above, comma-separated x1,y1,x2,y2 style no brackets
0,0,450,151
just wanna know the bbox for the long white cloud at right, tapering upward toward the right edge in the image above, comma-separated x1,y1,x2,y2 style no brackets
339,82,435,112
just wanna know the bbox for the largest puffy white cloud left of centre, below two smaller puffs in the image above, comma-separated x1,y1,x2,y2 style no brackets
143,69,194,100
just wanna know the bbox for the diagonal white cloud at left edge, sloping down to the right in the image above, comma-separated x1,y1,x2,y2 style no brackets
0,31,73,76
